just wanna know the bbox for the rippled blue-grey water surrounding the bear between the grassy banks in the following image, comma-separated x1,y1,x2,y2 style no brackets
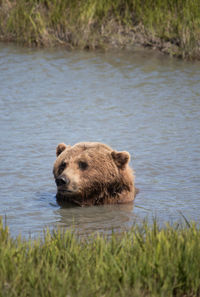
0,44,200,237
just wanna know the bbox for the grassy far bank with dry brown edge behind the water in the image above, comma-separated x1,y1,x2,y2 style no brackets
0,0,200,59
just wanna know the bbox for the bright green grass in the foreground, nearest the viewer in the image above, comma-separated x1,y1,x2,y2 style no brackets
0,217,200,297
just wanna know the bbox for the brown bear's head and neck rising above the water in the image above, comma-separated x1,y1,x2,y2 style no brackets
53,142,136,206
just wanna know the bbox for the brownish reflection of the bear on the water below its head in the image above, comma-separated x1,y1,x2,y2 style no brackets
56,203,134,235
